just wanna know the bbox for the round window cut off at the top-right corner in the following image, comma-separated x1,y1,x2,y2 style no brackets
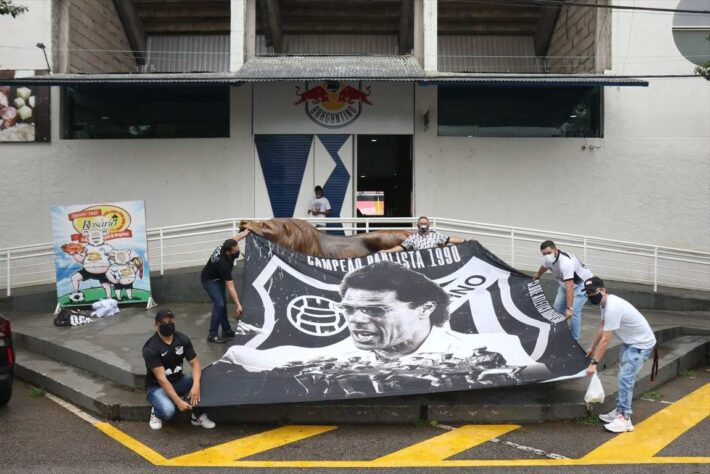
673,0,710,66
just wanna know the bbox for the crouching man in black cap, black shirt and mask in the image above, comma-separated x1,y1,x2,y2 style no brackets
143,309,215,430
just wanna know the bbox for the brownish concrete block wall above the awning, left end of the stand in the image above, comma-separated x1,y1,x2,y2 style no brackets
69,0,136,73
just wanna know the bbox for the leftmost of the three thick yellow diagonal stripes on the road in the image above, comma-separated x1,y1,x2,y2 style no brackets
169,426,338,466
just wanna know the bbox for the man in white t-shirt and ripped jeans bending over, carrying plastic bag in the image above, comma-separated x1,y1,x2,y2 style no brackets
584,277,656,433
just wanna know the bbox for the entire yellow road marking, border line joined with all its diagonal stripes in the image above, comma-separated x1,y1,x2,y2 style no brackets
95,384,710,468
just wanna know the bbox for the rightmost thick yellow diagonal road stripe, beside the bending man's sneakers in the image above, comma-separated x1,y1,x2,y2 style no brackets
583,383,710,460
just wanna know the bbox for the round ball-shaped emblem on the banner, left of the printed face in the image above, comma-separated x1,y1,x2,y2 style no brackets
286,295,348,337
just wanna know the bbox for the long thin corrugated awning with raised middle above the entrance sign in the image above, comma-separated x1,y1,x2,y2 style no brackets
0,56,648,87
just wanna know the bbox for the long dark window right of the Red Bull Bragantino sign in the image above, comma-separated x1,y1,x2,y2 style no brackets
438,86,602,137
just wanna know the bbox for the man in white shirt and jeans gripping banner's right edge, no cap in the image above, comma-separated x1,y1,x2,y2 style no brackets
533,240,593,341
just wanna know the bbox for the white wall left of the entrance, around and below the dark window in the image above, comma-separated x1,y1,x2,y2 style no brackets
0,86,254,248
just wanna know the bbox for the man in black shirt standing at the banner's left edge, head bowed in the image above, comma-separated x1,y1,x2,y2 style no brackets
200,230,249,344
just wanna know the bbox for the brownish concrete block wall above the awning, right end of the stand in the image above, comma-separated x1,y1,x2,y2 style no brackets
547,0,599,74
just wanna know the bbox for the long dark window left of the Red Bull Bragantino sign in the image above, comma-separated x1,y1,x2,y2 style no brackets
63,85,229,139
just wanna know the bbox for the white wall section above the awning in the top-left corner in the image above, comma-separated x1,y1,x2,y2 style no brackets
0,1,52,69
